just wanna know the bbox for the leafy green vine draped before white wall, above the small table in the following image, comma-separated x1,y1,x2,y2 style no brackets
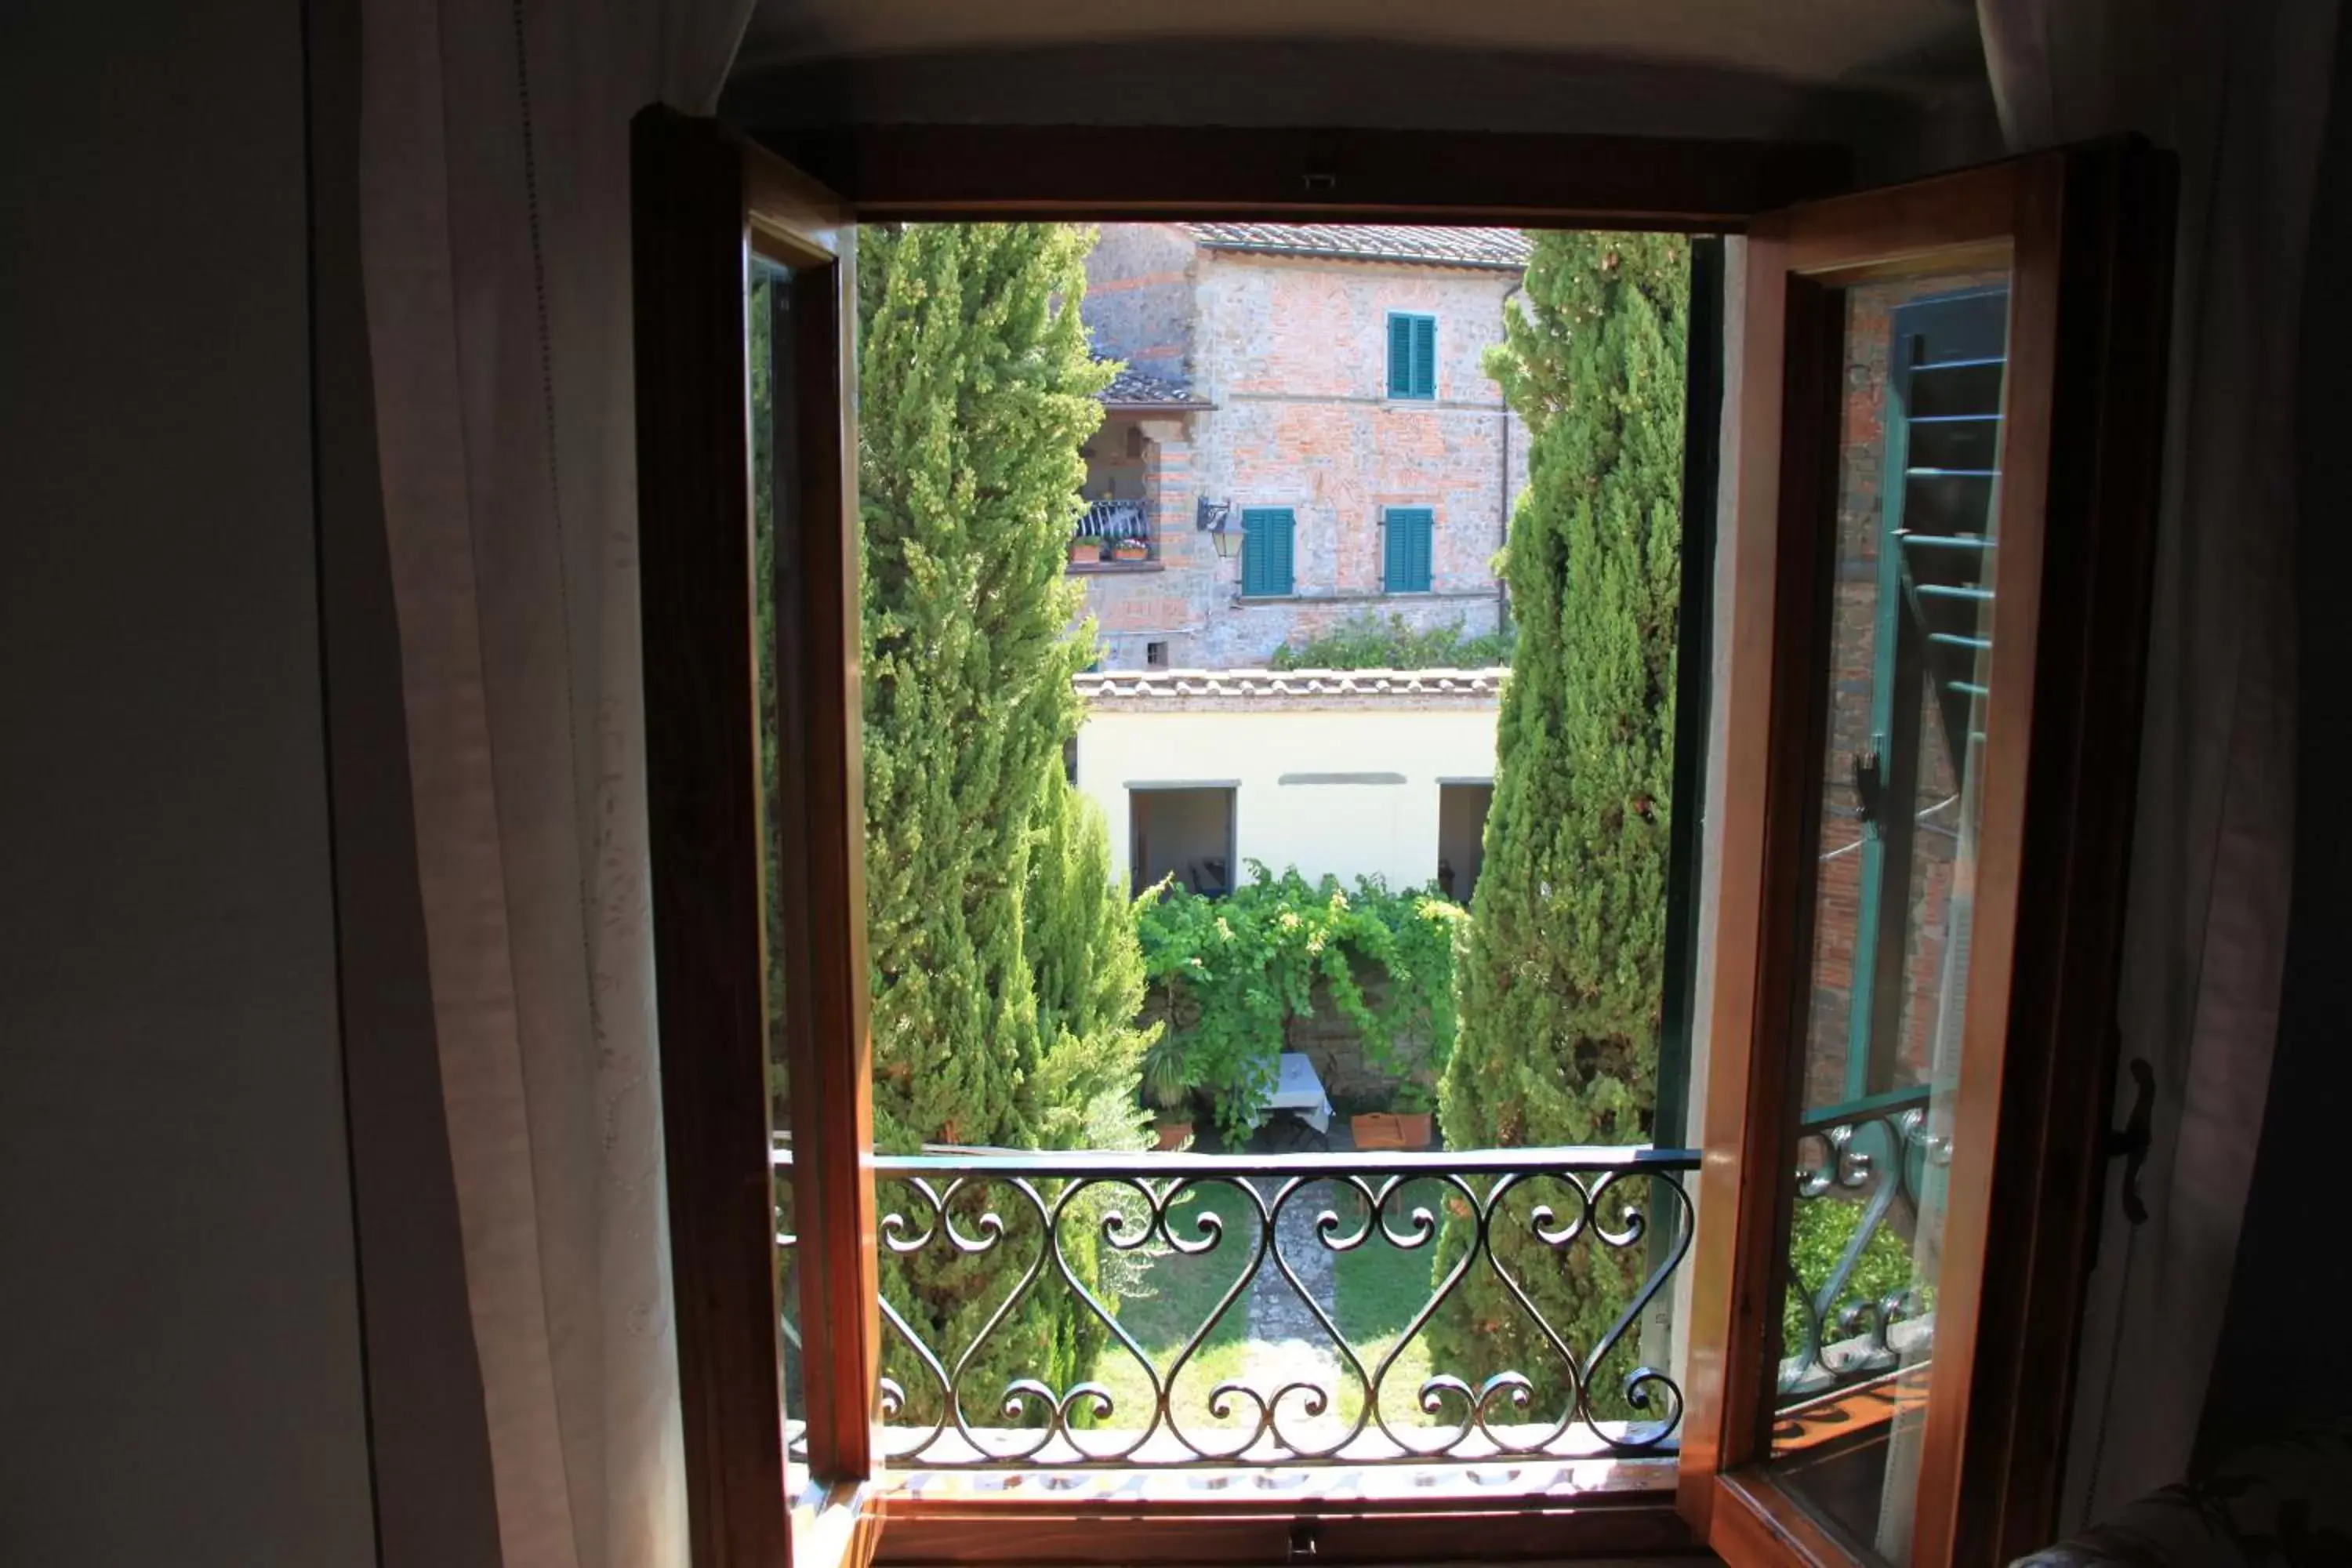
1138,860,1463,1142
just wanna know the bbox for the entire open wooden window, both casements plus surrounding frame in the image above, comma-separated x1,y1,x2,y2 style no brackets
635,111,2169,1568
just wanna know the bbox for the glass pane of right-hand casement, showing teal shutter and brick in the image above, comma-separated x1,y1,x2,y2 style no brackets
1771,275,2009,1563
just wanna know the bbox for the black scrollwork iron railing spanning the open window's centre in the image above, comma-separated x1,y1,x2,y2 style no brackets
779,1147,1698,1469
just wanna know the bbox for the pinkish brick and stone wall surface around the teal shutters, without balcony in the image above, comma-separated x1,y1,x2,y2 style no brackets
1087,223,1526,670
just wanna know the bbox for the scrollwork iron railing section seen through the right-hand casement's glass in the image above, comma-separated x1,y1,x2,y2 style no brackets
1778,1083,1952,1408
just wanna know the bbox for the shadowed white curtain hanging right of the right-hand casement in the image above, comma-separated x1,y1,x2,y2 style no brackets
1978,0,2336,1528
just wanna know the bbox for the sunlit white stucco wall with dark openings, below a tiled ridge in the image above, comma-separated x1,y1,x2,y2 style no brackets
1077,703,1494,888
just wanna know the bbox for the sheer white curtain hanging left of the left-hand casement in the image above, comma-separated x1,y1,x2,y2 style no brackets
360,0,750,1568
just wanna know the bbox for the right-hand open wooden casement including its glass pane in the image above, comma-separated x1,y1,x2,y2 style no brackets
1679,148,2169,1568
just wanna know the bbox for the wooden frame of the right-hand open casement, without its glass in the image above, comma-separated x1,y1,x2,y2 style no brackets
1677,143,2171,1568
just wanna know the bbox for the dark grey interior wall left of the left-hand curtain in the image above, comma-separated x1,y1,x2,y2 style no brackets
0,0,376,1568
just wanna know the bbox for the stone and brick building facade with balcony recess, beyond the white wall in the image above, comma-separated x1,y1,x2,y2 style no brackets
1073,223,1526,670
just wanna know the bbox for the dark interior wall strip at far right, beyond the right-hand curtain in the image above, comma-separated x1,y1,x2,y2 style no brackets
2197,0,2352,1467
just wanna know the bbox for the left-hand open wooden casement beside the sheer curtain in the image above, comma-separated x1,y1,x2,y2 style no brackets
633,111,880,1568
